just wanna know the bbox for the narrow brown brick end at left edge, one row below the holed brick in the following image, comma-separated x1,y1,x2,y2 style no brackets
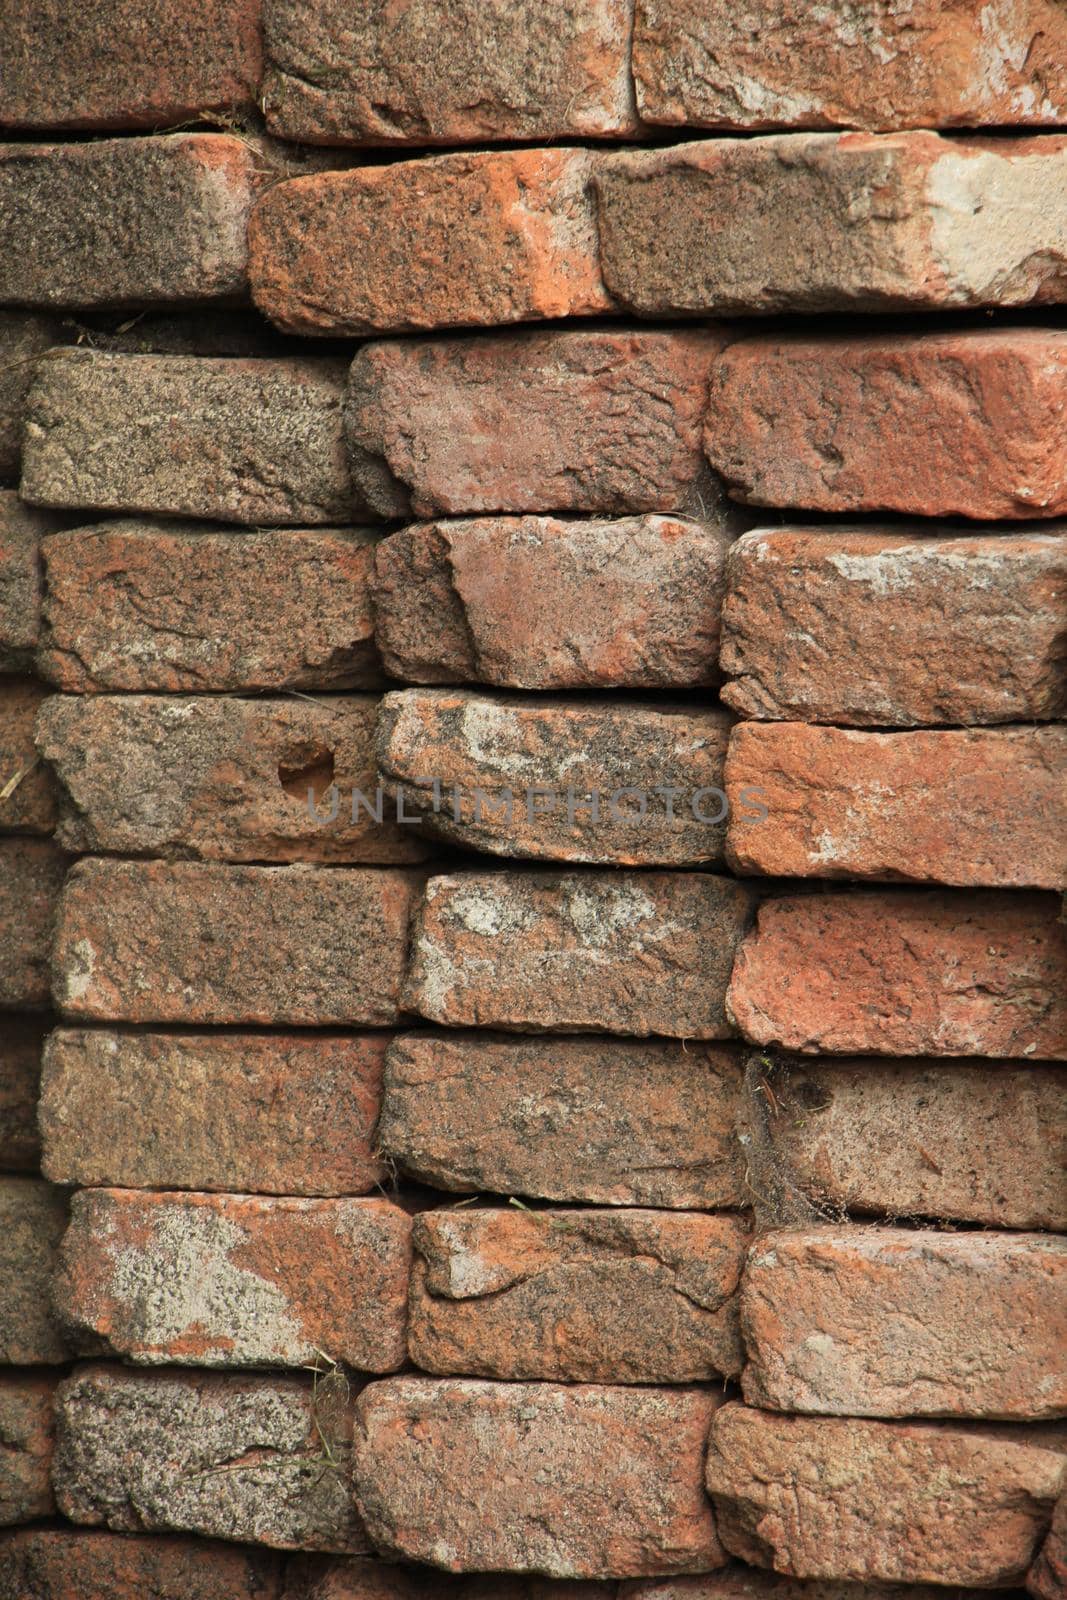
0,838,67,1011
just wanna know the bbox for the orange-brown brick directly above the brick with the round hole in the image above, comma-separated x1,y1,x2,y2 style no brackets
38,520,382,694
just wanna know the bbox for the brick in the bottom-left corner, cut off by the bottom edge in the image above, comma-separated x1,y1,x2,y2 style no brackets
0,1528,282,1600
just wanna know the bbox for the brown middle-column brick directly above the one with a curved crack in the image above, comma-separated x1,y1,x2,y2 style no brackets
378,1032,745,1210
